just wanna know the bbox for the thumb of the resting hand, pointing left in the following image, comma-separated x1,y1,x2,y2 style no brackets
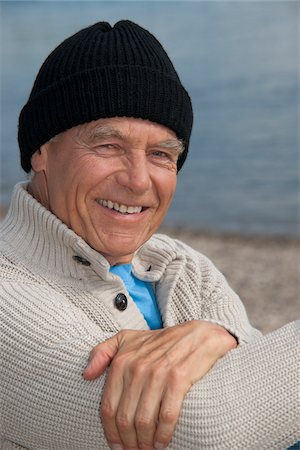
82,334,119,380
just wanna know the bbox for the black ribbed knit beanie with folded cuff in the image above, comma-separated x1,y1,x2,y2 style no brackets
18,20,193,172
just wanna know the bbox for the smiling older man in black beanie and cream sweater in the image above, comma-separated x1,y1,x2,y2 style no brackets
1,21,297,450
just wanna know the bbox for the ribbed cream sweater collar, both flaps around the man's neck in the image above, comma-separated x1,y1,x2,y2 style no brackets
0,183,176,281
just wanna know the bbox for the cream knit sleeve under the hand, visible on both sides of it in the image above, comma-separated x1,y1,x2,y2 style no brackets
0,282,299,450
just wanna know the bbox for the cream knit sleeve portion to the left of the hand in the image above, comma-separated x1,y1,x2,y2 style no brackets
0,282,115,450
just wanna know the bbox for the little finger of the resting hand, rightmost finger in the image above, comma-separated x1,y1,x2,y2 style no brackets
154,385,186,449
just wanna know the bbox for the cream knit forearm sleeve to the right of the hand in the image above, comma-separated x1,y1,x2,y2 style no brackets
169,322,300,450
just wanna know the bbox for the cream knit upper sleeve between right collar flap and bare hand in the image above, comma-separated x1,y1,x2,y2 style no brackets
164,241,261,344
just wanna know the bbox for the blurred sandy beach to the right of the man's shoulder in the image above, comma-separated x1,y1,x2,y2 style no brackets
160,228,300,333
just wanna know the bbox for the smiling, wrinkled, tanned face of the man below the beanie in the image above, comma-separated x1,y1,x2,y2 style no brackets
31,118,182,265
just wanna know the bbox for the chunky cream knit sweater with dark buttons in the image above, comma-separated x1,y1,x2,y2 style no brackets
0,185,300,450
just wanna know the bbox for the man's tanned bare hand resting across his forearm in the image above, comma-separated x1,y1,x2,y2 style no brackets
83,320,237,450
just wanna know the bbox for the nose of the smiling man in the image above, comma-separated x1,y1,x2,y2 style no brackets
117,152,152,195
